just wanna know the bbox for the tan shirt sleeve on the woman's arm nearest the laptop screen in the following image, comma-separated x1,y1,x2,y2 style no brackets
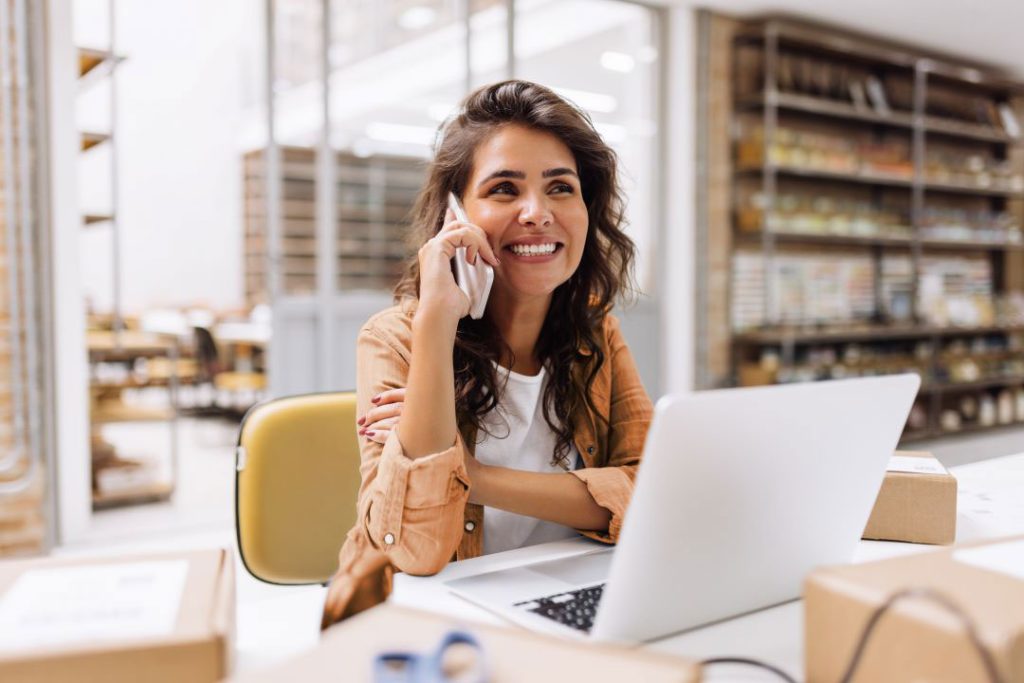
572,315,653,543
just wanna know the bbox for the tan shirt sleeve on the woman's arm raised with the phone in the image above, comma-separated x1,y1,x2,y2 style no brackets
356,317,470,574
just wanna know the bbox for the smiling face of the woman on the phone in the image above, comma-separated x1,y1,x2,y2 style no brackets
462,124,589,299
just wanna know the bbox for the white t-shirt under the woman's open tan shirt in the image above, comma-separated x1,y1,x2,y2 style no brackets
475,366,580,555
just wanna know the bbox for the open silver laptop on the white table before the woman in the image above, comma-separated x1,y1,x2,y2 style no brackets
445,374,921,642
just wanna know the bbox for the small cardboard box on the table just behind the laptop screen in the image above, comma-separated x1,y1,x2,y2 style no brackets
862,451,956,545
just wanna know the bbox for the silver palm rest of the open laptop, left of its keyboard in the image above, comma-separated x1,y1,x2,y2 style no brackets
445,550,612,605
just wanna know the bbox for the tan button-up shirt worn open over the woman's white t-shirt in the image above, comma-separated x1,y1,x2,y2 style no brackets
324,306,652,628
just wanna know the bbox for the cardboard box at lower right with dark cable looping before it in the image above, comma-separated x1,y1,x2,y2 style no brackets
804,537,1024,683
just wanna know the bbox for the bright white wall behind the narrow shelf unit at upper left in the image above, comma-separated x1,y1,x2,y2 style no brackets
74,0,248,313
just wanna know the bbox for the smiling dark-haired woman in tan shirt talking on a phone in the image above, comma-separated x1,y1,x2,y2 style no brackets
324,81,651,627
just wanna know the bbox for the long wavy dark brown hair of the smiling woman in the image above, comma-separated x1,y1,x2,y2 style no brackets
394,81,636,467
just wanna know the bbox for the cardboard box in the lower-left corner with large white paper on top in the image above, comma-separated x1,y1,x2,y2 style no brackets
0,550,234,683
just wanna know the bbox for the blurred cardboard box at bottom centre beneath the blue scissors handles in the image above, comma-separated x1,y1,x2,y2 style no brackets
237,604,700,683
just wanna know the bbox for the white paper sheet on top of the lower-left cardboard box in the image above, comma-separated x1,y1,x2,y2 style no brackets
0,559,188,650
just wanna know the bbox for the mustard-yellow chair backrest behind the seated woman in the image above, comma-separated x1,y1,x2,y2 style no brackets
234,392,359,584
